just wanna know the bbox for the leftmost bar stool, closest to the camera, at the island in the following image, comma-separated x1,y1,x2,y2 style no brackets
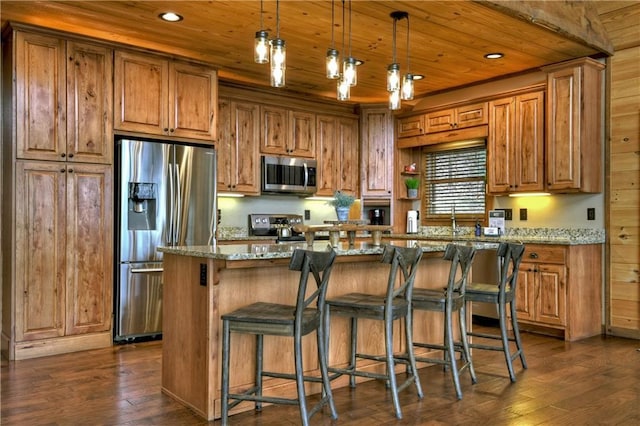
221,249,338,425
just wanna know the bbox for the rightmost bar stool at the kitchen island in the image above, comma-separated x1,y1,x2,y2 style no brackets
466,243,527,382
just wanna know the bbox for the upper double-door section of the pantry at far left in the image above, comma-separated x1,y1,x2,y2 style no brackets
15,32,113,164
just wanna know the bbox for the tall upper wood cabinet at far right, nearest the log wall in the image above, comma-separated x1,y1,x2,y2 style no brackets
543,58,604,193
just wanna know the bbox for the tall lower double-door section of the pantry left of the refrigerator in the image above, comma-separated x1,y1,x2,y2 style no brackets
3,161,113,359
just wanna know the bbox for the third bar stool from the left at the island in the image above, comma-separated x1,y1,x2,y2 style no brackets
412,244,477,399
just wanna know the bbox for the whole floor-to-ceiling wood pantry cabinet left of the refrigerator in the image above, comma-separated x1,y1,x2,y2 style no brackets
2,26,113,359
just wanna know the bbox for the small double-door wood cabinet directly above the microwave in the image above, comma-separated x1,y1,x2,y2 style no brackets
260,105,316,158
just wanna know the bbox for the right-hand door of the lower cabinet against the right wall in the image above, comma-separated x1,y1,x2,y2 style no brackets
536,264,567,325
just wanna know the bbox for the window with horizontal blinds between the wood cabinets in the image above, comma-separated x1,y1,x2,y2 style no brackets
424,140,487,220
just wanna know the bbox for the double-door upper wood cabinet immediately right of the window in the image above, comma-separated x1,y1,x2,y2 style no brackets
487,91,544,194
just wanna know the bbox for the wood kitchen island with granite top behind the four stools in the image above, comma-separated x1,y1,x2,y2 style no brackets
160,240,496,420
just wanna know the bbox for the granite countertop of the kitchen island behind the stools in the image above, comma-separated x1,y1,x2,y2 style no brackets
158,239,497,260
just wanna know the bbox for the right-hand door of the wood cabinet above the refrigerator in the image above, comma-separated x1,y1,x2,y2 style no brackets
168,62,217,141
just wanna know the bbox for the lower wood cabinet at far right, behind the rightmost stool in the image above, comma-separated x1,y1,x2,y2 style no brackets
516,244,603,340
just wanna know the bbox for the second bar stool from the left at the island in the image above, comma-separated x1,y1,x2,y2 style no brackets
325,245,423,419
